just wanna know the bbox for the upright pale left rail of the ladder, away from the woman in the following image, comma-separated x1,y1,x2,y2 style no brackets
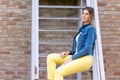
31,0,39,80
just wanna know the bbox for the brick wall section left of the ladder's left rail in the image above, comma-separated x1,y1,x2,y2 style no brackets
0,0,31,80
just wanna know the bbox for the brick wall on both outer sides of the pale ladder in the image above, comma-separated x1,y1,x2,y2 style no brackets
0,0,120,80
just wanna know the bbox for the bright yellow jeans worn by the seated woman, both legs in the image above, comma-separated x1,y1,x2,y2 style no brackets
47,53,93,80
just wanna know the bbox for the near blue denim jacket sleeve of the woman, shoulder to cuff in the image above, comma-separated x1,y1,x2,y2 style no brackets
72,28,96,60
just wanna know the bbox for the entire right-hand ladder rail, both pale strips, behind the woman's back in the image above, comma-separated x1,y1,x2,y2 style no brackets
87,0,105,80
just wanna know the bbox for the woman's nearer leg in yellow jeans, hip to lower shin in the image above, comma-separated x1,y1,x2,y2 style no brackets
54,56,93,80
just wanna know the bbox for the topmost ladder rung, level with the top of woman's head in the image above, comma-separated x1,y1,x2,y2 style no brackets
39,5,84,9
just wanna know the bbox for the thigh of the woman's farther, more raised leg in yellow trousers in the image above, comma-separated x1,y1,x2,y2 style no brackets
48,53,71,65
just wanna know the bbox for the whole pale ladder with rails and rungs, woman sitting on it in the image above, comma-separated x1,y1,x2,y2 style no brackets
31,0,105,80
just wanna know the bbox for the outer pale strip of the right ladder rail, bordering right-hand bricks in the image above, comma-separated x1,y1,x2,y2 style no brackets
93,0,105,80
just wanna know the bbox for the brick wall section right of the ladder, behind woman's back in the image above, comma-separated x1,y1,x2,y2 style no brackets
98,0,120,80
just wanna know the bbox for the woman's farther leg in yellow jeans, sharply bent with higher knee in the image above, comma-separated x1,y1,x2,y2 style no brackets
47,53,71,80
